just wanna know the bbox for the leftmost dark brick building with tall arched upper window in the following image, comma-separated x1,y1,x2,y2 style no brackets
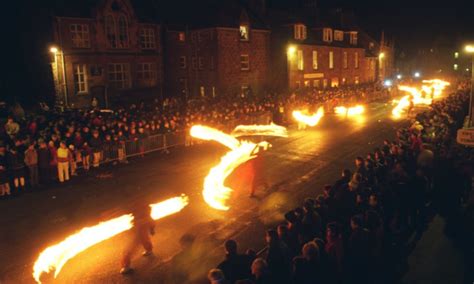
51,0,163,108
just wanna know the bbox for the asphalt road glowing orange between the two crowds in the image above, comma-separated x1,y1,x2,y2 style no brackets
0,103,403,283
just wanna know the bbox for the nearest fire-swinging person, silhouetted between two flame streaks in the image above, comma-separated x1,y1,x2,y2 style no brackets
120,204,155,274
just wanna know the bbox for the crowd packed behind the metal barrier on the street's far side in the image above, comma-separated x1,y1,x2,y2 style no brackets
0,85,386,197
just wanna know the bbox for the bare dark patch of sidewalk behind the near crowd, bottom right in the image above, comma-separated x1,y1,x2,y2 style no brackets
402,215,466,284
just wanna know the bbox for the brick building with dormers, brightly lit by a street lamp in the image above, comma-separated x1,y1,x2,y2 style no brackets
269,6,377,90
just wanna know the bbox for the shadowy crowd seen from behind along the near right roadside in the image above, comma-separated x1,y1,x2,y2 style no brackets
208,82,474,284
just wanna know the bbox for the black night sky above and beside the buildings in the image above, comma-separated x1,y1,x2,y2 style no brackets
0,0,474,104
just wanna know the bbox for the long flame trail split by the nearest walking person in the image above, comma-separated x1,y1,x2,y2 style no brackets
33,195,189,283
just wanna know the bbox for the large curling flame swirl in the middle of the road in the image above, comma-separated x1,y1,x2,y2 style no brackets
191,125,286,210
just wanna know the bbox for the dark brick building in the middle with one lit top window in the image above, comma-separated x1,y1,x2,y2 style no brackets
164,1,270,98
